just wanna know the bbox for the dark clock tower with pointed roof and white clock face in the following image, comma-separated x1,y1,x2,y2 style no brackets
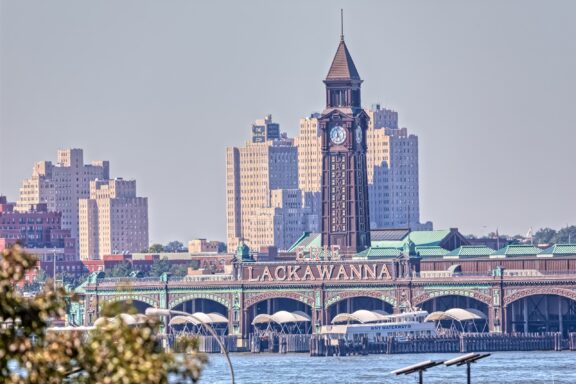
319,16,370,256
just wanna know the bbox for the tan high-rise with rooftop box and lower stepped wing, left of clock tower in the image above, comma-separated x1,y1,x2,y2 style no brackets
226,116,317,252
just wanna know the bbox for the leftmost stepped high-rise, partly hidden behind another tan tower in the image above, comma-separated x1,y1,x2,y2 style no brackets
16,149,110,254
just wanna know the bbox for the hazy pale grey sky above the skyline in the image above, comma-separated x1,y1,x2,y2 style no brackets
0,0,576,242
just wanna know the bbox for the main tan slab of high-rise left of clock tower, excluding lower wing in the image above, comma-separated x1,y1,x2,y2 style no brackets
226,138,298,249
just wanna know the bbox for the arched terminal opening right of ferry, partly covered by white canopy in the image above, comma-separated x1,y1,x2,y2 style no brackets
420,295,489,333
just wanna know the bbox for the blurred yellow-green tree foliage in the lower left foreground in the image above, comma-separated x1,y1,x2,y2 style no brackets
0,246,206,384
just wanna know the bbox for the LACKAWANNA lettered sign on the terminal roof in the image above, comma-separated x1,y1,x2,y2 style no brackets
242,263,392,282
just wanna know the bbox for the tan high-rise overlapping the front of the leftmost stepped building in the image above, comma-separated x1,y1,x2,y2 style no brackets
79,178,148,260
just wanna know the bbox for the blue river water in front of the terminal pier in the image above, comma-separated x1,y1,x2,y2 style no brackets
195,352,576,384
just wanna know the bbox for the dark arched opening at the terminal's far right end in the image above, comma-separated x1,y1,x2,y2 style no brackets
506,295,576,337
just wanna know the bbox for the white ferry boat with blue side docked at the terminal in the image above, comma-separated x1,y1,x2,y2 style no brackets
320,310,436,344
